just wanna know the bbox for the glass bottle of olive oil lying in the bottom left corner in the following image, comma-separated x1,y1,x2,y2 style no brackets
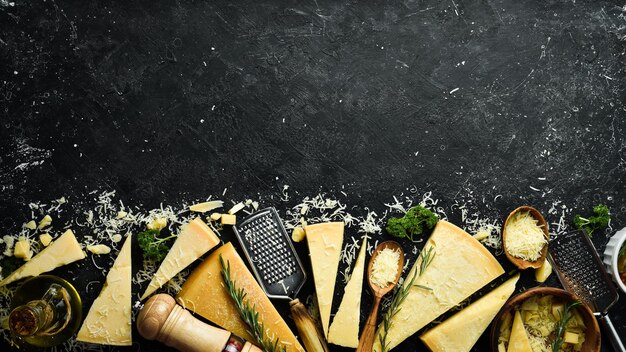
9,275,82,350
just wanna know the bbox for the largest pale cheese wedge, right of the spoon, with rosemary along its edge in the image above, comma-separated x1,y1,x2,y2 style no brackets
374,220,504,351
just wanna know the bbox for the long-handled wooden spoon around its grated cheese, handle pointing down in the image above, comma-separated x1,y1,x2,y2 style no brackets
356,241,404,352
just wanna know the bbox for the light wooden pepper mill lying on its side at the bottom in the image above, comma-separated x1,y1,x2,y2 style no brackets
137,294,262,352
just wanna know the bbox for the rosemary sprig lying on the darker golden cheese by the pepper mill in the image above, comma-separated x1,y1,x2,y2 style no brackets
220,255,287,352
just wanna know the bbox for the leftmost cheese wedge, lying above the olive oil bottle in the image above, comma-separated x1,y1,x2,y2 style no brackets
0,230,85,286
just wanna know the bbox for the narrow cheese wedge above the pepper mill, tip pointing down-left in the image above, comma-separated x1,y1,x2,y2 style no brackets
141,218,220,300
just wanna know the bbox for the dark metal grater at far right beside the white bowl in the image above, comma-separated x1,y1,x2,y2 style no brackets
548,231,625,351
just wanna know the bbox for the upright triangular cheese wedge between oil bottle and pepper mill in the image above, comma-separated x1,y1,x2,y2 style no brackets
76,235,133,346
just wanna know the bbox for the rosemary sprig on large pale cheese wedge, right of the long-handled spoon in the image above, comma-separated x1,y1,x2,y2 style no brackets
378,246,435,352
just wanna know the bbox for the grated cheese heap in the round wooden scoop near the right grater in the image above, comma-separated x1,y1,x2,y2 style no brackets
505,211,548,262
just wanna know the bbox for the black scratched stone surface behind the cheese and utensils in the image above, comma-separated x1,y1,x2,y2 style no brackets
0,0,626,351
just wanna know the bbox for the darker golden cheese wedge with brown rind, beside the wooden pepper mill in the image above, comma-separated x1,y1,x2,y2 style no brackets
176,242,304,352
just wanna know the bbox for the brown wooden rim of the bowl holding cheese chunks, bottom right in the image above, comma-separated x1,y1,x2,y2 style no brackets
490,287,602,352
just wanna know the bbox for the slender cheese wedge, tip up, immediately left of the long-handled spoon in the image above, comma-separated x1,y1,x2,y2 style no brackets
328,238,367,348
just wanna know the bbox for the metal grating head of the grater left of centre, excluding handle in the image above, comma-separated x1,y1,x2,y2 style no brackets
233,207,306,299
